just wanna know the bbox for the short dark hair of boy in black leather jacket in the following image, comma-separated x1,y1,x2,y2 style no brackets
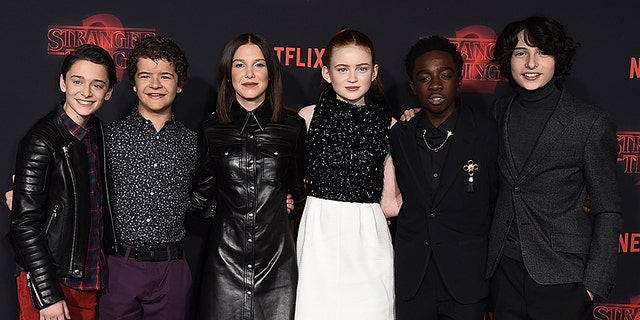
60,44,118,89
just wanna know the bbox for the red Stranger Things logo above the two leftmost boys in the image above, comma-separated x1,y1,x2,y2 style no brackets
47,14,156,79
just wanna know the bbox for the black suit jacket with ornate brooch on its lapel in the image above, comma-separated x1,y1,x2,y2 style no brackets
391,104,498,303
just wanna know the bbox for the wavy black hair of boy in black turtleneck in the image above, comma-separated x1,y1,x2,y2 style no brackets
493,16,579,85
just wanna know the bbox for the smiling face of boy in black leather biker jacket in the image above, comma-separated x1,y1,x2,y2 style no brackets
60,60,113,127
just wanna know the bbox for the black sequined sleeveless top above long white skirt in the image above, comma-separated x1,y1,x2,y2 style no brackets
306,90,391,203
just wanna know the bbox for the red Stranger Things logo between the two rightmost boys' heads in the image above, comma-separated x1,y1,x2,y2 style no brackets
449,25,506,93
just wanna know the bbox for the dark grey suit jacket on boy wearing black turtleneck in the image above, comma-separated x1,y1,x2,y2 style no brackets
487,91,622,297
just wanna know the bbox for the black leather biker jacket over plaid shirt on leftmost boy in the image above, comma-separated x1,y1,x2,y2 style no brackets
11,108,116,309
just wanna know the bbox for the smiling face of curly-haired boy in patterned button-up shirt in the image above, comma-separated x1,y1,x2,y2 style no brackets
133,58,182,119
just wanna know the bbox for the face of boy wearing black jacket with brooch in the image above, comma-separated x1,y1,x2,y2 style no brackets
410,50,462,127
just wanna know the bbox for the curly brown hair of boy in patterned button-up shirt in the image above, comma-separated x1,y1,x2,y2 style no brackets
127,36,189,87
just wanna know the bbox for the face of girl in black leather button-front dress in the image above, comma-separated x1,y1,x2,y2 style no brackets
231,43,269,110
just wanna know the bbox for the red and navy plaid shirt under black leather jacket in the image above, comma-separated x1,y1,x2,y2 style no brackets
58,107,105,290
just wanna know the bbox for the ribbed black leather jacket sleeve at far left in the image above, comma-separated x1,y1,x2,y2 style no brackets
11,131,65,309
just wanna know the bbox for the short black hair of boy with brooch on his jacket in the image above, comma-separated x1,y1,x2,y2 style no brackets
404,36,464,81
